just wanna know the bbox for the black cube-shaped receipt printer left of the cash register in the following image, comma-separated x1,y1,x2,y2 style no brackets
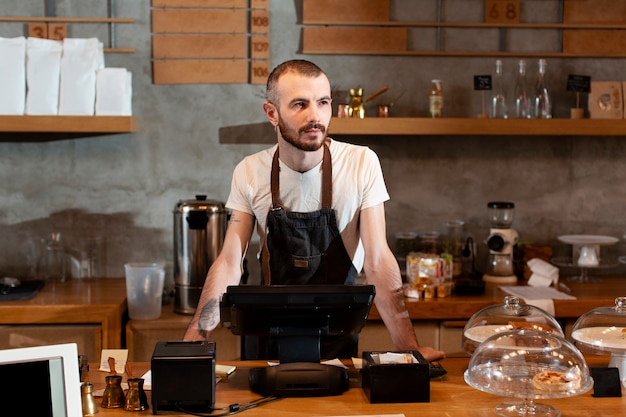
150,341,215,414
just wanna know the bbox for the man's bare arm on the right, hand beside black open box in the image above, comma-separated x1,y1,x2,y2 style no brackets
360,203,445,361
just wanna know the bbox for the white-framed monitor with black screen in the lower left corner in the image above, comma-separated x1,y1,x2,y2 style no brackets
0,343,82,417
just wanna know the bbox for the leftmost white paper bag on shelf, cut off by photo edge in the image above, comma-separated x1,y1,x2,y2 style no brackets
0,36,26,115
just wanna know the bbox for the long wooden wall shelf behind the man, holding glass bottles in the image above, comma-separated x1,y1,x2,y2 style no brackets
219,117,626,144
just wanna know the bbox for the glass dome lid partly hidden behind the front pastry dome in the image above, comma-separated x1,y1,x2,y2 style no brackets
462,295,564,354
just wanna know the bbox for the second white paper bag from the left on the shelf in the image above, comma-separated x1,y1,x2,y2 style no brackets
26,38,63,115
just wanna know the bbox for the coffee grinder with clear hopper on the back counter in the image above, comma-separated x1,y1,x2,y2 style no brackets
483,201,519,284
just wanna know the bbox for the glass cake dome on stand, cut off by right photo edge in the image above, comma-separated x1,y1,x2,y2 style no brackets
572,297,626,387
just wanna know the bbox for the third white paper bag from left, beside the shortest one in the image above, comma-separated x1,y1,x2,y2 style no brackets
59,38,104,116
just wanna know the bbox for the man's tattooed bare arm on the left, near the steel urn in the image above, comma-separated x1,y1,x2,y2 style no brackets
183,210,254,340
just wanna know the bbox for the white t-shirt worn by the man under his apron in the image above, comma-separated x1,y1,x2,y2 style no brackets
226,140,389,271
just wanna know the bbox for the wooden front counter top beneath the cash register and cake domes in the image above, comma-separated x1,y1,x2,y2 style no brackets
89,356,626,417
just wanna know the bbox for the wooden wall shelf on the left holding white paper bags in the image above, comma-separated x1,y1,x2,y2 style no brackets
0,116,138,142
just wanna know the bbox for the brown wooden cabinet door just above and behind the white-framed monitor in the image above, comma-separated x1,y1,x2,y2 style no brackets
0,324,102,362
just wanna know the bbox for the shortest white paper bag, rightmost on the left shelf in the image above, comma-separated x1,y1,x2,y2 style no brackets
96,68,133,116
